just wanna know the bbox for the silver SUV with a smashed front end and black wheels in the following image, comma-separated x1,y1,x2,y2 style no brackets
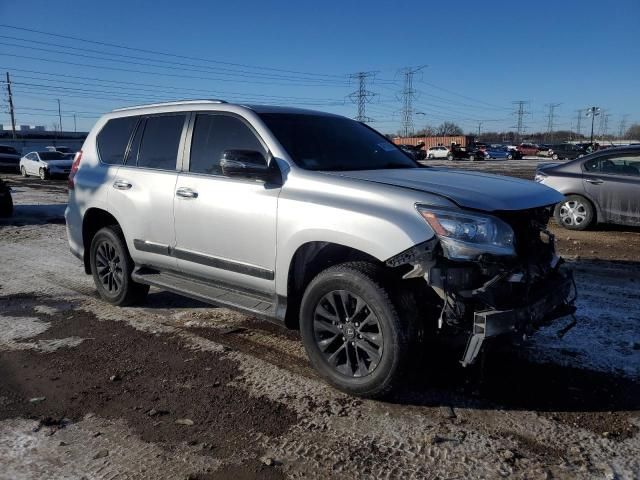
66,100,574,397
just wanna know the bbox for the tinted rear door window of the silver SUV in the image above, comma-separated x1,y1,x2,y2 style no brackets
138,115,185,170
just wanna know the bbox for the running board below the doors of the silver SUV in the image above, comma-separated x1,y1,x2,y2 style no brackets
131,268,276,319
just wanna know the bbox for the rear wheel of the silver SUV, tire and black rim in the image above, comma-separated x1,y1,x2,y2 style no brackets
89,226,149,307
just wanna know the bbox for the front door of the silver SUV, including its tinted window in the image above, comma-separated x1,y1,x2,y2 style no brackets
175,113,280,293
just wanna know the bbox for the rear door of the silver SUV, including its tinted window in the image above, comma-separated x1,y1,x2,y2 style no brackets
109,113,188,270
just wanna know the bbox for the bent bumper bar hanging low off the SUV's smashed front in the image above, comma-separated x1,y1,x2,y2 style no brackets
461,272,576,367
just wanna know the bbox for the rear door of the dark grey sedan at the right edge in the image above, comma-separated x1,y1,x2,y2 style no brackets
583,153,640,225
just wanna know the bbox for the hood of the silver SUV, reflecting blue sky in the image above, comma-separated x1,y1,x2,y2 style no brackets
327,168,564,212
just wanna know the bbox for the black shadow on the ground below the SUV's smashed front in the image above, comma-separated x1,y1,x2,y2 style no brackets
391,347,640,412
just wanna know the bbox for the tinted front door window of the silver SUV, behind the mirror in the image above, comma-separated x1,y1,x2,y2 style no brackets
189,115,266,175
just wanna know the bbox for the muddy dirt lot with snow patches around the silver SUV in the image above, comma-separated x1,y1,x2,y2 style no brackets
0,171,640,480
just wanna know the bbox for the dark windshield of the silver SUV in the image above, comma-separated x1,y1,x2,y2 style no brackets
260,113,419,170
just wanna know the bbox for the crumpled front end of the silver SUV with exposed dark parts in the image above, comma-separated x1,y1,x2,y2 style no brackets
387,207,576,366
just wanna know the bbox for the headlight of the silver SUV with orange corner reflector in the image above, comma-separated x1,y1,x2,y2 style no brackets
416,205,516,260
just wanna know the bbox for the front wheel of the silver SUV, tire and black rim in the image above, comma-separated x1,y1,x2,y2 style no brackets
300,262,414,398
